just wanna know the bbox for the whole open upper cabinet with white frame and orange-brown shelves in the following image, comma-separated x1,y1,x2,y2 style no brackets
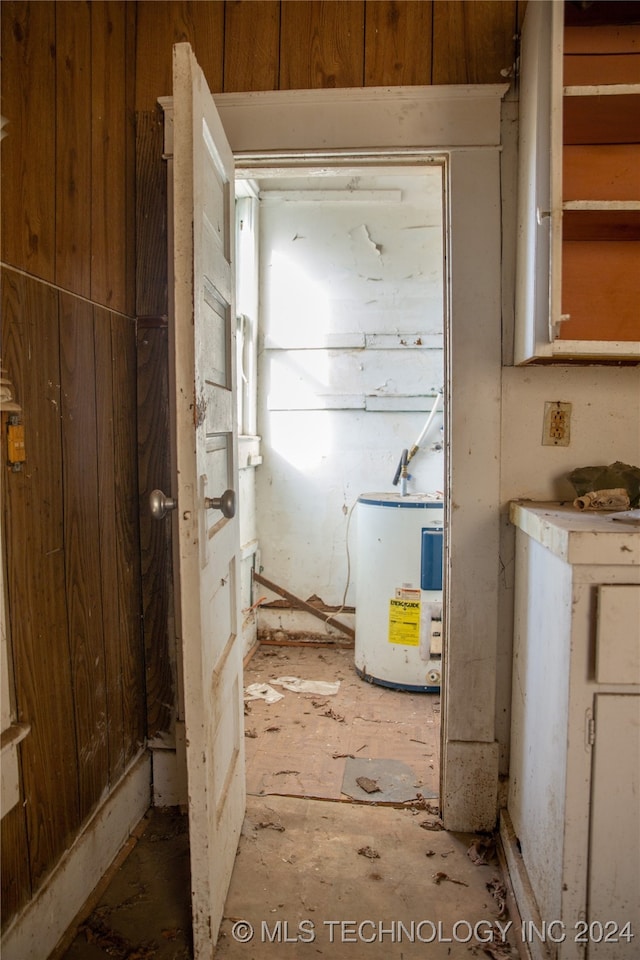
514,0,640,364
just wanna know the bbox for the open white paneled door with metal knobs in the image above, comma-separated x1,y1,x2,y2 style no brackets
173,43,245,960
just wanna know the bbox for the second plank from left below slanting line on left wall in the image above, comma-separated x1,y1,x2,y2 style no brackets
60,294,108,819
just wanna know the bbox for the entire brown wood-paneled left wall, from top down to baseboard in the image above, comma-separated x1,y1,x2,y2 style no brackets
0,2,146,925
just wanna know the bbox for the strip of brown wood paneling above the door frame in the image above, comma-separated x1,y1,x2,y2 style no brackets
136,0,523,111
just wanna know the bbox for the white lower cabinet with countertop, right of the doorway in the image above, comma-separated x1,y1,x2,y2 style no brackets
507,502,640,960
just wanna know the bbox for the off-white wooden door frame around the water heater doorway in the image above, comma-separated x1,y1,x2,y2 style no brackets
214,84,508,831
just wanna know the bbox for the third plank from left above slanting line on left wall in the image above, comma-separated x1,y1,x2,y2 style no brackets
91,0,130,312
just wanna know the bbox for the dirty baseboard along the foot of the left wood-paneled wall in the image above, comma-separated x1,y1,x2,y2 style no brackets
2,750,151,960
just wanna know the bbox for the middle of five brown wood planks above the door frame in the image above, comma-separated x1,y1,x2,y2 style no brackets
280,0,364,90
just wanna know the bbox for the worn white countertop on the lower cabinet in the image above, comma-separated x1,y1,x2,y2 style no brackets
509,500,640,566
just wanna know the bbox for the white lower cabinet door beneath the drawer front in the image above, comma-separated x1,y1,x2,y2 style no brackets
585,694,640,960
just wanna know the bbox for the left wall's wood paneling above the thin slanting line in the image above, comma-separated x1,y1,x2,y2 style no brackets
1,0,135,316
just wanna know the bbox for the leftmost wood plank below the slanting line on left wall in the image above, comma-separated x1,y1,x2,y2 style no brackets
2,270,80,890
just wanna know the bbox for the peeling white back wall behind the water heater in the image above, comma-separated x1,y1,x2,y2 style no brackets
256,172,444,604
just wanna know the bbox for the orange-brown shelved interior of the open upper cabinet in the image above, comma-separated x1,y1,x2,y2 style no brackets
559,21,640,344
